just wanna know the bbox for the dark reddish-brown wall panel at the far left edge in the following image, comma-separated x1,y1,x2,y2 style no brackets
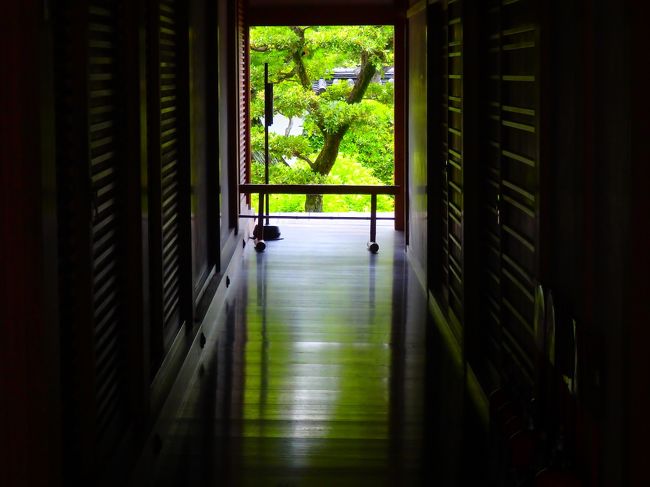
0,1,61,485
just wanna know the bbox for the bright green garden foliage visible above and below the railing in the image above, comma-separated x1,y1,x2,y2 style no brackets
250,26,394,211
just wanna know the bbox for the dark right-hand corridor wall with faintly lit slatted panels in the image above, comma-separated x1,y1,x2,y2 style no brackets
407,0,650,485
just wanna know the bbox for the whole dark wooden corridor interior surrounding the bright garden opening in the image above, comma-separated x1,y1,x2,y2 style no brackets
0,0,650,487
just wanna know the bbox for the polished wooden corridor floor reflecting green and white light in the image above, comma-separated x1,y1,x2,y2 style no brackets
150,221,425,487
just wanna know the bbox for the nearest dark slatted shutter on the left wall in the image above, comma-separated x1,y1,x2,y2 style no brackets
88,0,128,450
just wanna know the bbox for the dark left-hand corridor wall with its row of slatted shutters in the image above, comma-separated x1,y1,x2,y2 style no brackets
0,0,247,485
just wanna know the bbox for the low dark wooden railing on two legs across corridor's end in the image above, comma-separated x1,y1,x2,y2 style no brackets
239,184,399,254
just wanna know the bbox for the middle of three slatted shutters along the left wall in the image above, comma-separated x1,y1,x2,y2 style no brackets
149,0,190,371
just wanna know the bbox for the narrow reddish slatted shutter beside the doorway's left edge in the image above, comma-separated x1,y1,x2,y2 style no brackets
237,0,251,208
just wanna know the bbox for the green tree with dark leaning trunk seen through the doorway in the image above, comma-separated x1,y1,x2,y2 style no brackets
250,26,393,211
